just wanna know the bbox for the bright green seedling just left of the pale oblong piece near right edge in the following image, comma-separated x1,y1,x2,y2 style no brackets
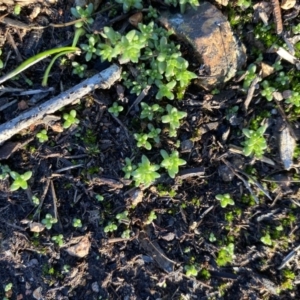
243,125,267,158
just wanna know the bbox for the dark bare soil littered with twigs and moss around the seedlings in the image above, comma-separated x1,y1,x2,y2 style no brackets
0,0,300,300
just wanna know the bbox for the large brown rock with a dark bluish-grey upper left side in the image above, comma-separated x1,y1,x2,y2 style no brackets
159,2,246,90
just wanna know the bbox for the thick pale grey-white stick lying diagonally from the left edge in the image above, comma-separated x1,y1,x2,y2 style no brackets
0,65,121,145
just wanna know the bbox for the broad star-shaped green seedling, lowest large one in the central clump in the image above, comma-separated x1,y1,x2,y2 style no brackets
132,155,160,187
